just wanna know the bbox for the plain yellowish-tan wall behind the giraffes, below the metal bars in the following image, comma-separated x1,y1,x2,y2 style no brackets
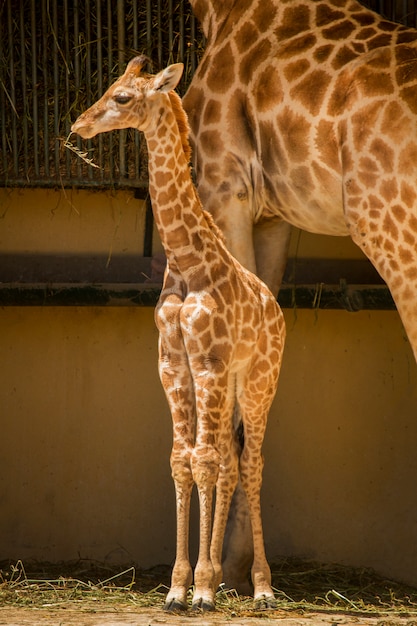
0,191,417,584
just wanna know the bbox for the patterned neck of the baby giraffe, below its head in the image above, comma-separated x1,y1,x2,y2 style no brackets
144,95,215,279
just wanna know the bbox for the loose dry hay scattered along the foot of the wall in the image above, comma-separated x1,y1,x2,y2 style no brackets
0,559,417,626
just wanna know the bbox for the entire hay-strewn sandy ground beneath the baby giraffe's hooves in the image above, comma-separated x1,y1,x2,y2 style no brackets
0,560,417,626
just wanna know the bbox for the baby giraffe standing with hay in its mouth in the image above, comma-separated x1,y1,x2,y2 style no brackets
72,56,285,611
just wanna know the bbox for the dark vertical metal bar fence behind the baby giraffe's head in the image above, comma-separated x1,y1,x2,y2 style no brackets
0,0,417,187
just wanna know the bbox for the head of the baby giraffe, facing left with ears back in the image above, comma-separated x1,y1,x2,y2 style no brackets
71,56,184,139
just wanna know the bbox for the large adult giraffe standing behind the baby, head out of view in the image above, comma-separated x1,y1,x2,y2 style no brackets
184,0,417,587
